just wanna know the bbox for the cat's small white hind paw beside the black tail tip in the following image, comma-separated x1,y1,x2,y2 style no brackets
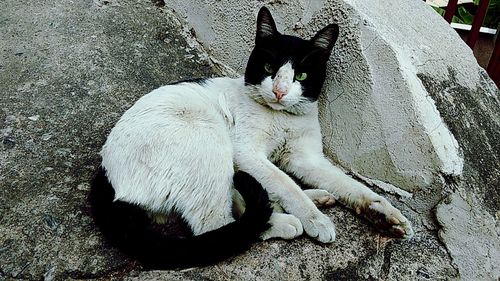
260,213,304,240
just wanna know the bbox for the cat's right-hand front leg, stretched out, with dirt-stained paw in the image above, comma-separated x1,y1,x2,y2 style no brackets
282,149,413,238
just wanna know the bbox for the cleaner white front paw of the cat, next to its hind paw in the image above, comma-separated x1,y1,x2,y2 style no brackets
301,212,335,243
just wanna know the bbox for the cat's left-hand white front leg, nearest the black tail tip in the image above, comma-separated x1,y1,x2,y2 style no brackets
237,151,335,243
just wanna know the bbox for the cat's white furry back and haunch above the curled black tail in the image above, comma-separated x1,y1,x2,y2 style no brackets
101,83,233,234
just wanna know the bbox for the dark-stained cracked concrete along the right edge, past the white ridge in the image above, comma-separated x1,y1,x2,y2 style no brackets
419,65,500,280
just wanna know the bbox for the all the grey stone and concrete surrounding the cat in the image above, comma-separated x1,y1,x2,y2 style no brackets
0,0,500,280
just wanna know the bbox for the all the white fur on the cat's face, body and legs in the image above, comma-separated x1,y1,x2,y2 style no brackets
101,63,411,242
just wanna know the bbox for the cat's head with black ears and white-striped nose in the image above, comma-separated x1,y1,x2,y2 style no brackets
245,7,339,114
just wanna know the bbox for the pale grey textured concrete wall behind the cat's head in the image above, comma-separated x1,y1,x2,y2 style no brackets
168,0,466,197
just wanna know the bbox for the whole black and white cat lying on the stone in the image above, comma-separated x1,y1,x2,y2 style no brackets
91,8,413,268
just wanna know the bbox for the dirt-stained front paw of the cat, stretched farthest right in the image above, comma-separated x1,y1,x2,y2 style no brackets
356,197,414,239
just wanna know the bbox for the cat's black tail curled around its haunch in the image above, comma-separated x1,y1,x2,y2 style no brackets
89,168,272,269
